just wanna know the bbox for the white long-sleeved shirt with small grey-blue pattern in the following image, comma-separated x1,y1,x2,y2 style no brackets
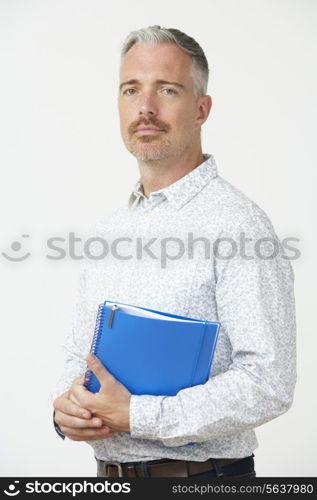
52,154,296,462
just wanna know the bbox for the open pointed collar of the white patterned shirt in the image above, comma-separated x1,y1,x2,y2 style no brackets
128,153,217,210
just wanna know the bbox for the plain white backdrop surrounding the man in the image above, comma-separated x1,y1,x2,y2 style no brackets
0,0,317,476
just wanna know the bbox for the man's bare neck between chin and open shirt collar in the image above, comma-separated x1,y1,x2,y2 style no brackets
138,146,205,197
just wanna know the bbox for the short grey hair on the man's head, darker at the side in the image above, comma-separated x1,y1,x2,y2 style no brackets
121,25,209,97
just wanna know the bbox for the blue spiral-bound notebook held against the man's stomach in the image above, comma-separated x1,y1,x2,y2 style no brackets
84,300,220,396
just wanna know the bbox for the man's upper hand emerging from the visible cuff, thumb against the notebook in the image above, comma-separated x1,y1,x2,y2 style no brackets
69,354,131,432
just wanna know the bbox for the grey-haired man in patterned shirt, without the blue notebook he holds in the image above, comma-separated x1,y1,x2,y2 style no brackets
54,26,296,478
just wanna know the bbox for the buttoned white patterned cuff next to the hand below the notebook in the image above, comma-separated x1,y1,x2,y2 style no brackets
129,394,165,439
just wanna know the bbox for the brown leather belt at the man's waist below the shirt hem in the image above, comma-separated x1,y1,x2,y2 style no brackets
96,458,241,477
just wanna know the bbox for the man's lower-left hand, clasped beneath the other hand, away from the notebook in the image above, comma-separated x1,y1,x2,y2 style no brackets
53,377,114,441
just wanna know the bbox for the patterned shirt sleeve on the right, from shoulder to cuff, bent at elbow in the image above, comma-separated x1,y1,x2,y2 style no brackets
130,215,296,446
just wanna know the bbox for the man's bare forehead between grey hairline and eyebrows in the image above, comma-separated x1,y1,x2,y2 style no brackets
120,43,192,85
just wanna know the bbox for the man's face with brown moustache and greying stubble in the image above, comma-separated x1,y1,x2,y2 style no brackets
118,43,201,161
